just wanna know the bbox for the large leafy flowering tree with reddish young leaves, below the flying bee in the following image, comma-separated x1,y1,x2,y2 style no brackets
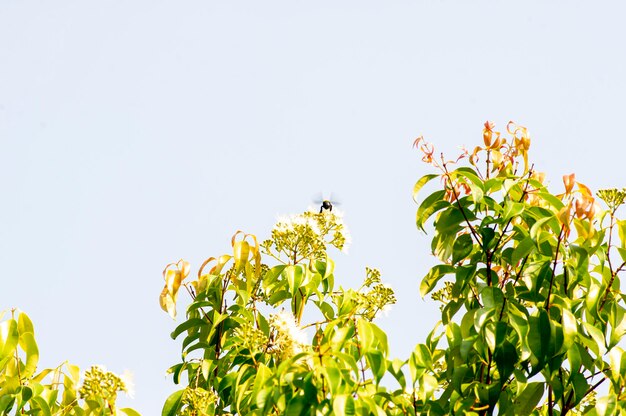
154,122,626,415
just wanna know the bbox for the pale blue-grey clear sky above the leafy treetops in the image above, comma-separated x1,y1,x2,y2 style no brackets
0,0,626,415
